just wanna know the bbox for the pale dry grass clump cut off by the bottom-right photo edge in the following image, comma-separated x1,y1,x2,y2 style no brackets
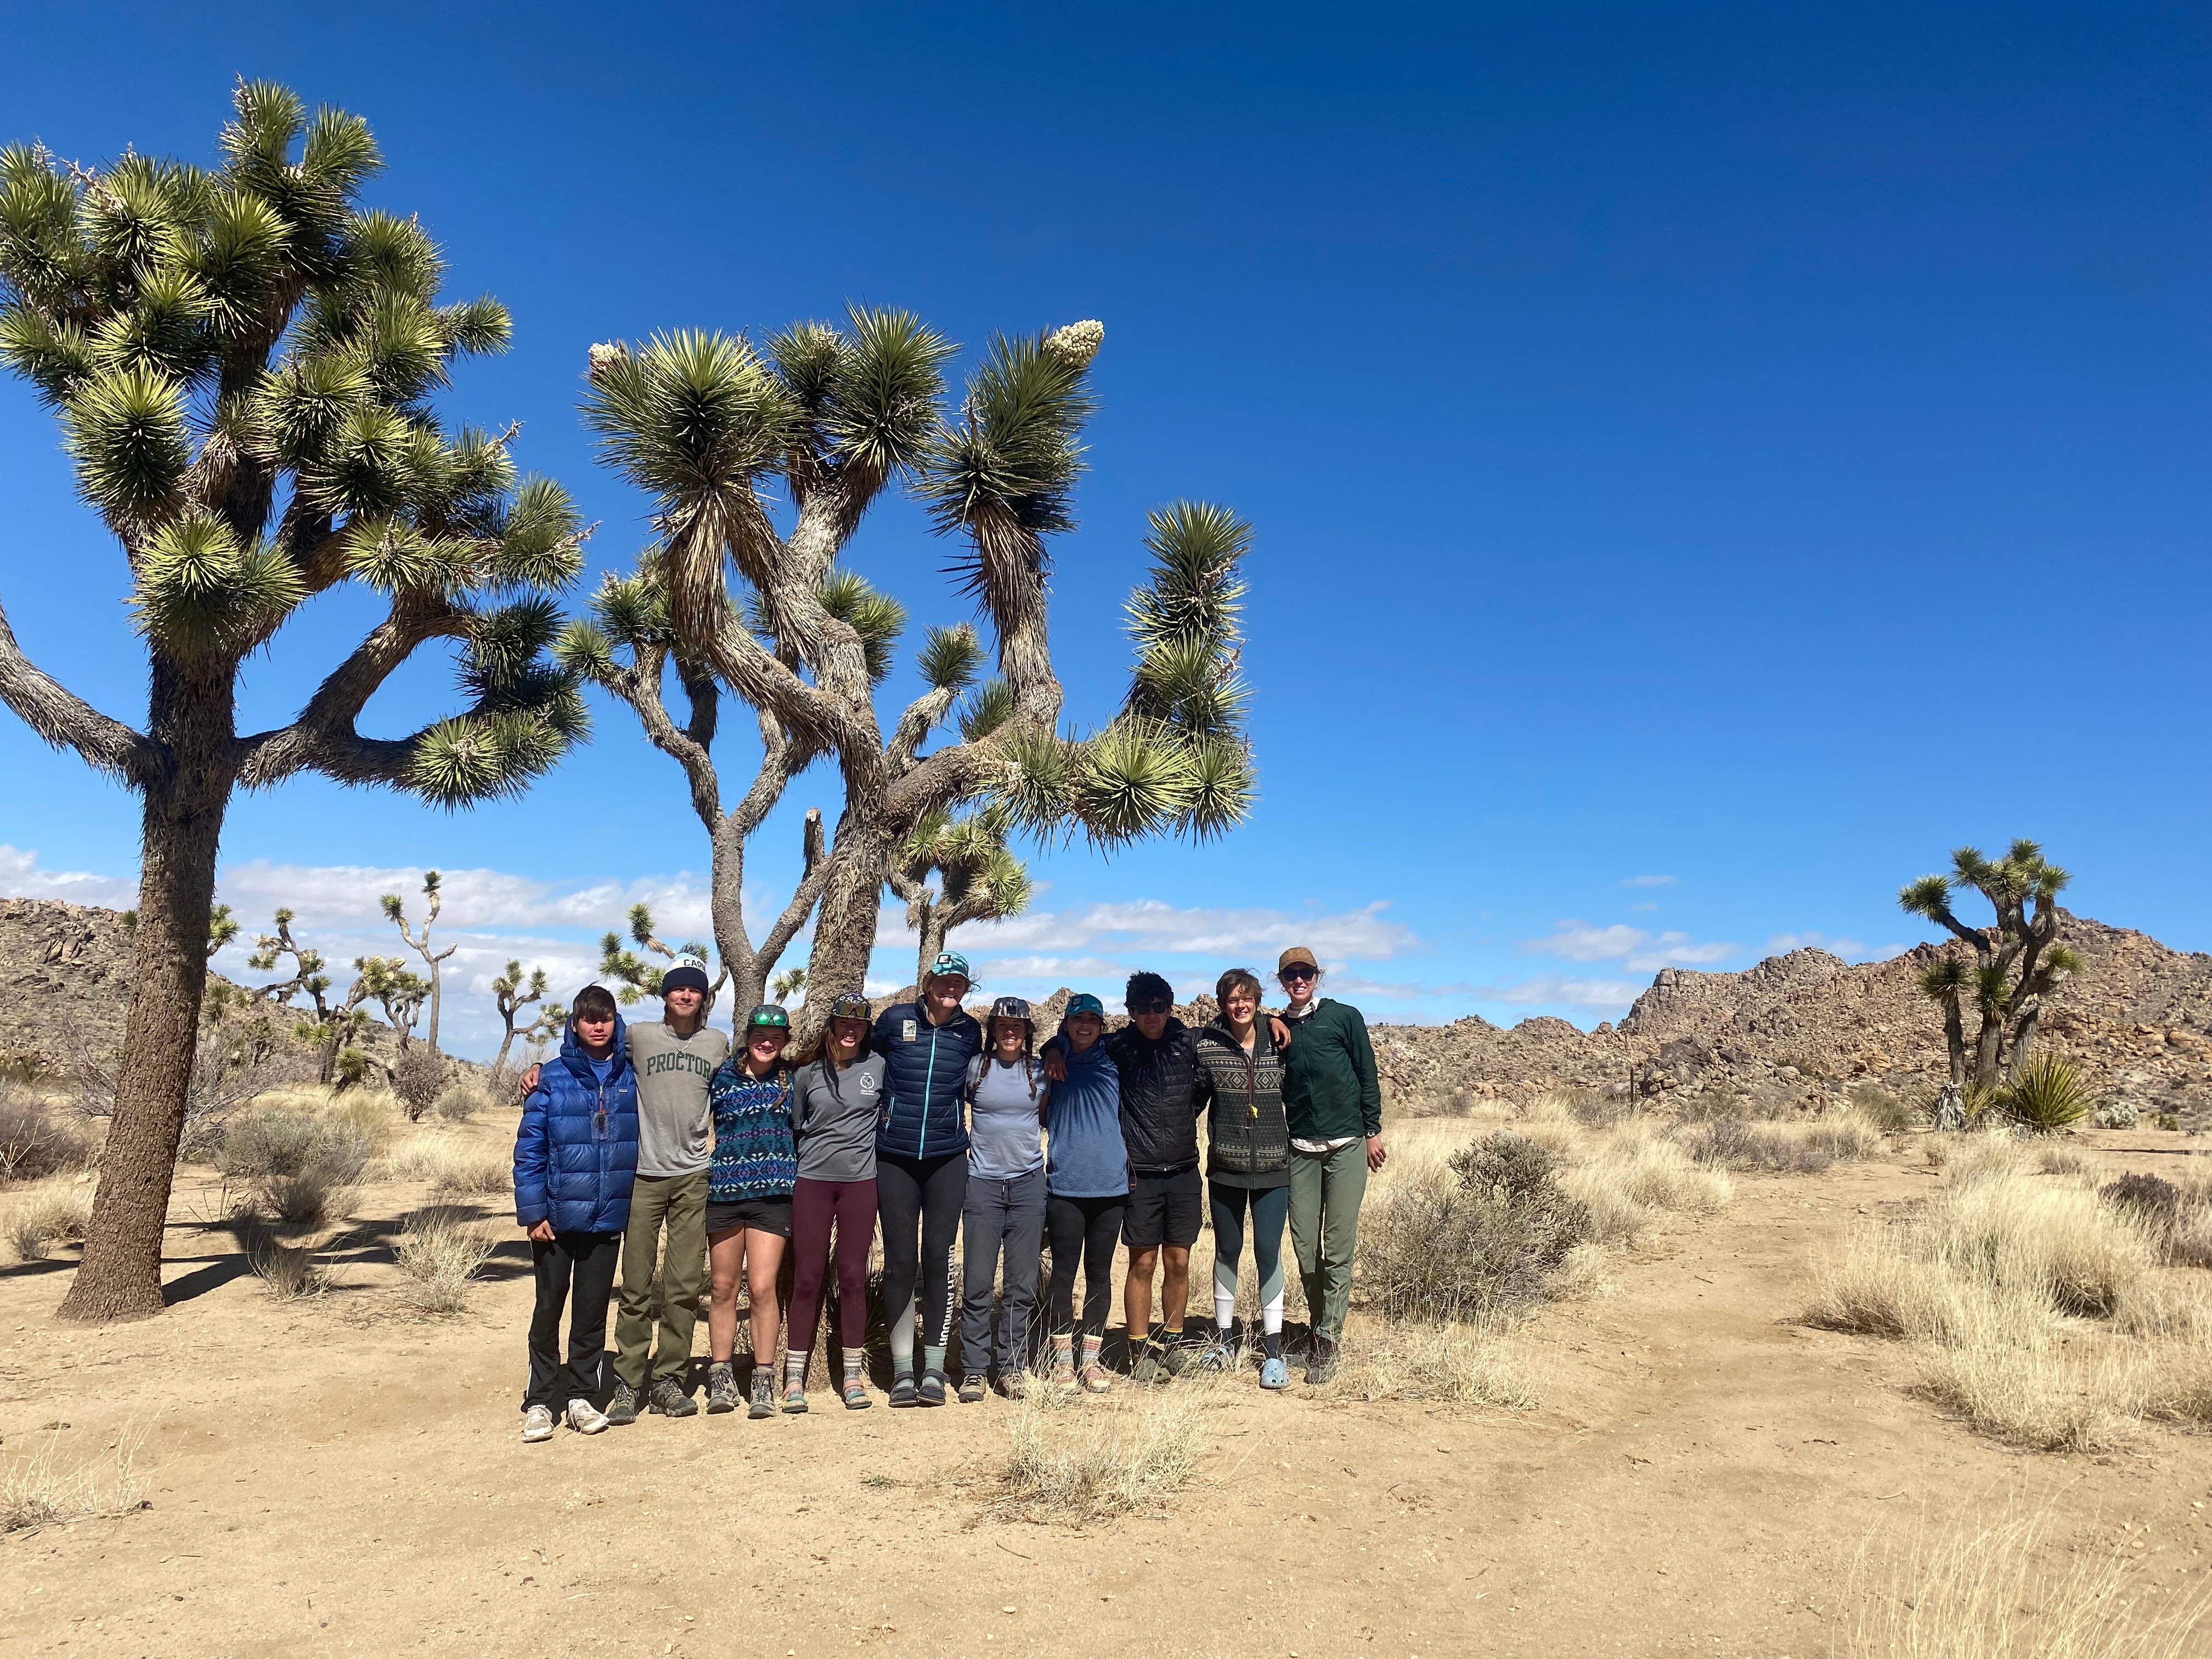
1845,1515,2212,1659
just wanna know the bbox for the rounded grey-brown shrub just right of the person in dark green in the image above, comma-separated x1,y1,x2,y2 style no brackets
1358,1130,1590,1323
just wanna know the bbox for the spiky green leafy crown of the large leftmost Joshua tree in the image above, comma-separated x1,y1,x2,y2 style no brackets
0,82,582,801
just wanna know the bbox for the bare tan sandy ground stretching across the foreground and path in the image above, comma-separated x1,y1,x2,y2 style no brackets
0,1159,2212,1659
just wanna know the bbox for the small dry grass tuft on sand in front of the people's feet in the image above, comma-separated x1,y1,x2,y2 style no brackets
993,1380,1219,1526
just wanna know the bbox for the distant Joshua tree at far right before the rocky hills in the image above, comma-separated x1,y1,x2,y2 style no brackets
1898,840,2081,1095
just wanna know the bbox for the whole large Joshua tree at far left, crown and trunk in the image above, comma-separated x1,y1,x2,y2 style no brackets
0,82,584,1318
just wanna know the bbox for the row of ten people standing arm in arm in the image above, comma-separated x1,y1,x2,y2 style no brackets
515,949,1385,1440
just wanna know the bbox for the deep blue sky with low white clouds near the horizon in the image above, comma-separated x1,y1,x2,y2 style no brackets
0,4,2212,1046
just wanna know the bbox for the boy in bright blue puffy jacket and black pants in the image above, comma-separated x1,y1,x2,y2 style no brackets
515,984,637,1440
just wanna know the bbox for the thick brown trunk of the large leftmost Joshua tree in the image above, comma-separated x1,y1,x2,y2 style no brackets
60,657,232,1321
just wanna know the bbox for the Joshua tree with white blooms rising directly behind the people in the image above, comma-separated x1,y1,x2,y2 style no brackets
562,309,1252,1035
